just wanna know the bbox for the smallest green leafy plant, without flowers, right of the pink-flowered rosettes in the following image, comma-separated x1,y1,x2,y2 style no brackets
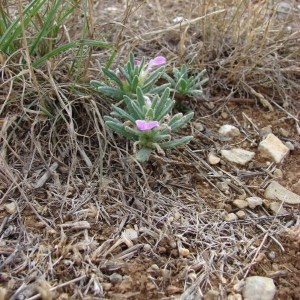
163,65,208,96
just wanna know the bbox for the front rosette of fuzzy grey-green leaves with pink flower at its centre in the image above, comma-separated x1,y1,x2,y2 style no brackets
104,87,194,161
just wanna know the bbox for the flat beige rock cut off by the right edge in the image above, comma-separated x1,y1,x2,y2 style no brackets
264,181,300,204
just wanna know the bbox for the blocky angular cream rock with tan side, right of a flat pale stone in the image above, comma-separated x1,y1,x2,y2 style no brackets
258,133,289,163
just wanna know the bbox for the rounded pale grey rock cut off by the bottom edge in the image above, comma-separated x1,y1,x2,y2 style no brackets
242,276,276,300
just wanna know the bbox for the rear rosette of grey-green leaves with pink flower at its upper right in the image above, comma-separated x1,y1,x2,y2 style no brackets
90,53,169,100
